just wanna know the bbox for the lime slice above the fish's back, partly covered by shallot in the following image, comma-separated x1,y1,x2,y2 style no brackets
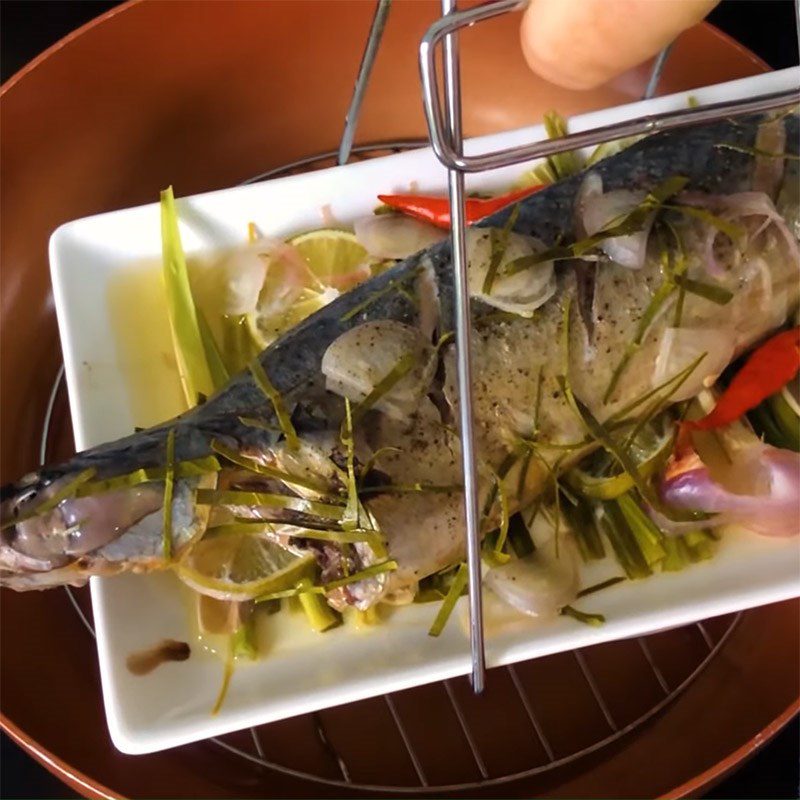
247,228,371,348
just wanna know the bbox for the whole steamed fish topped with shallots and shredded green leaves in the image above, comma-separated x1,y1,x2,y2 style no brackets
0,113,800,608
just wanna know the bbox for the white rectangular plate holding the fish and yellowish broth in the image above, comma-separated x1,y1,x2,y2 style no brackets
50,69,800,753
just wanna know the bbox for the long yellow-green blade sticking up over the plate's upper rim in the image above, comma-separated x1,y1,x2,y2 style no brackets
161,186,213,407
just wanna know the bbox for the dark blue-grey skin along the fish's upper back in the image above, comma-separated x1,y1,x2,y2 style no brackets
0,115,798,501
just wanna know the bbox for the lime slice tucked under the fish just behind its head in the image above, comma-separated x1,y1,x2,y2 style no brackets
177,531,314,601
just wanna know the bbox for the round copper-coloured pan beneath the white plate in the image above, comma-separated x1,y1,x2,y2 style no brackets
0,0,800,797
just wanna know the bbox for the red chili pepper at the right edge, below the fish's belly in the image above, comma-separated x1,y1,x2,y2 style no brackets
686,328,800,431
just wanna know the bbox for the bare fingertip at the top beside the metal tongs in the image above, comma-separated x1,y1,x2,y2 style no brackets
520,0,718,89
